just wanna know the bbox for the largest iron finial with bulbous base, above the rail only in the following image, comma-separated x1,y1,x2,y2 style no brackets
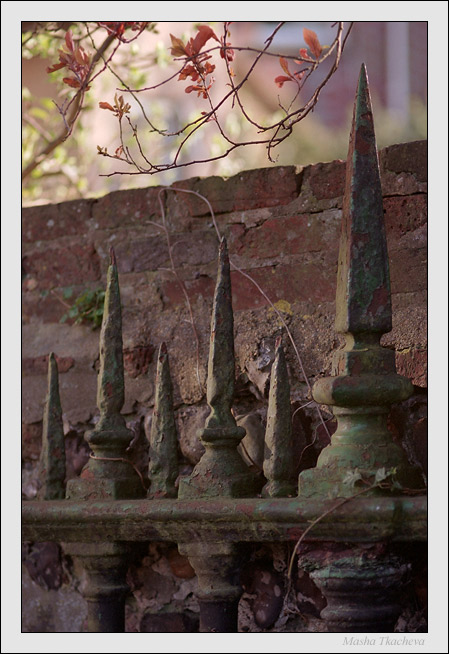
299,65,421,496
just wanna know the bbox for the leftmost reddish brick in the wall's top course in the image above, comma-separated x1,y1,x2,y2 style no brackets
22,200,93,243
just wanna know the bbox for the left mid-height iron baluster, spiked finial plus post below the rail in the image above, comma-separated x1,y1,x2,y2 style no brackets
65,249,145,633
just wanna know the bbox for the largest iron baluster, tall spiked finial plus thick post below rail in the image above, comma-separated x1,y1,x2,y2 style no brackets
299,65,422,632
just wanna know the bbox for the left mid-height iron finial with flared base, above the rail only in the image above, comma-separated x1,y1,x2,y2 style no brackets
67,248,144,499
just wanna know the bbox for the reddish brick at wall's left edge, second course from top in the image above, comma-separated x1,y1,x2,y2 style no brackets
22,243,100,290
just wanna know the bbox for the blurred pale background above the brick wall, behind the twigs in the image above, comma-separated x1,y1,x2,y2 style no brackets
22,21,427,206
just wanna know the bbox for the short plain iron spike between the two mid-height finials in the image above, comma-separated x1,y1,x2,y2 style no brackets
148,343,178,498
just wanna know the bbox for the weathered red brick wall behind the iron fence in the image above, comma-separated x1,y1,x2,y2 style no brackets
22,141,427,631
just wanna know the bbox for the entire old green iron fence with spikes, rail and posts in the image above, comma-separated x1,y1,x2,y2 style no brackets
22,66,427,632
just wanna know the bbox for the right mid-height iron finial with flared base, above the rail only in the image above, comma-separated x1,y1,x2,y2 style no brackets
179,238,259,497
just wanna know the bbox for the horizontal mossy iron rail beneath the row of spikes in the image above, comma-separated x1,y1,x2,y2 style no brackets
22,496,427,543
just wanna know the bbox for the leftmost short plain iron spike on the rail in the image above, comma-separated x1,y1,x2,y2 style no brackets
38,352,66,500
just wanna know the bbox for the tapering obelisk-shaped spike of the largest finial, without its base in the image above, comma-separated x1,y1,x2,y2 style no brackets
335,64,392,334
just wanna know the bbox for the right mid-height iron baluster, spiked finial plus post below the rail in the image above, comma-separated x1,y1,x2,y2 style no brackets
179,239,260,632
